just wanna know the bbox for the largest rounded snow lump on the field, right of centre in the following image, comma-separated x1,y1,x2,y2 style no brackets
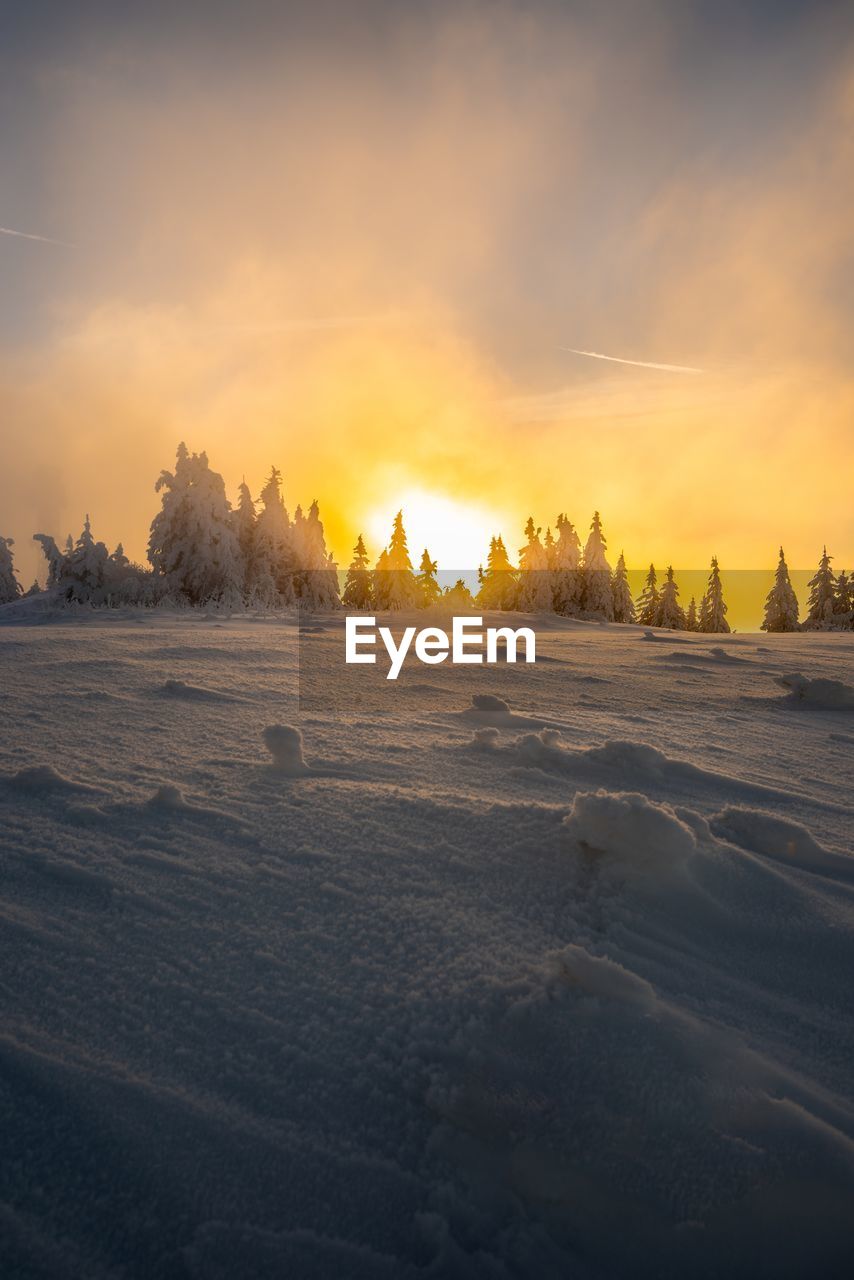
563,791,698,869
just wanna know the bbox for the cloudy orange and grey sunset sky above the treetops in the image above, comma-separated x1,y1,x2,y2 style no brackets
0,0,854,581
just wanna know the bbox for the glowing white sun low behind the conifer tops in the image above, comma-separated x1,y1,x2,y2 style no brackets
367,489,501,575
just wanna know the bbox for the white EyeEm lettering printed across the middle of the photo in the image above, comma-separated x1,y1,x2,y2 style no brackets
344,616,536,680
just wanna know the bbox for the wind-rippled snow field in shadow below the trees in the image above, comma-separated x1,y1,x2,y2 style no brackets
0,607,854,1280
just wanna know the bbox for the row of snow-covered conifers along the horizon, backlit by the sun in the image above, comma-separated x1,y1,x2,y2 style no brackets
0,444,854,634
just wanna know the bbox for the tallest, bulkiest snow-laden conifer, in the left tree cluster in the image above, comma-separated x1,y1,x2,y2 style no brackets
147,444,243,605
